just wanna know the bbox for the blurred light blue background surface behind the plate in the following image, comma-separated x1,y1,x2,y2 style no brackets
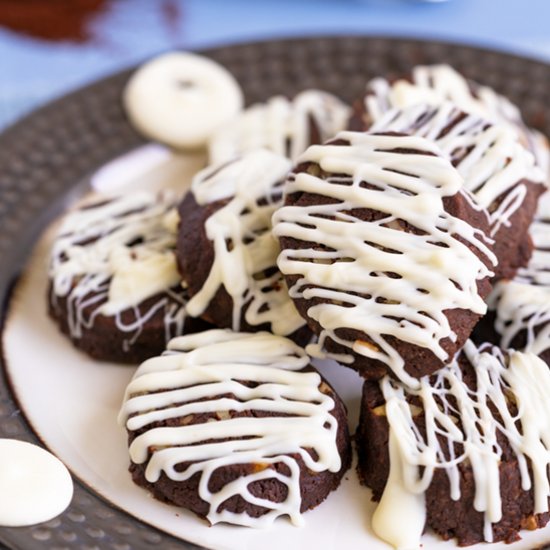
0,0,550,127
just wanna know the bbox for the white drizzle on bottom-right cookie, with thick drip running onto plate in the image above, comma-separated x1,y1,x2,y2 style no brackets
375,341,550,547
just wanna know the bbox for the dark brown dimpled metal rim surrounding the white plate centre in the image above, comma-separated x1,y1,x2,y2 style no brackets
0,35,550,550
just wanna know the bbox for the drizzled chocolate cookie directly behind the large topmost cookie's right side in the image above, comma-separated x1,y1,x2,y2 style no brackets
371,102,545,279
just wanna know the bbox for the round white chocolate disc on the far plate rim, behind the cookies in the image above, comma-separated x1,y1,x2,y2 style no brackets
124,52,247,149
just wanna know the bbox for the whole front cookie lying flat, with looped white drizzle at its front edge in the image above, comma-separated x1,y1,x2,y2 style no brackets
121,330,351,527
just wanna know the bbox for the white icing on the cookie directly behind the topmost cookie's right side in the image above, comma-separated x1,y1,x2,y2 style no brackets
371,101,545,236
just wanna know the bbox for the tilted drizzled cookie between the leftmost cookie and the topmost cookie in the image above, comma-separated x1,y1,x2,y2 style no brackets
177,149,311,343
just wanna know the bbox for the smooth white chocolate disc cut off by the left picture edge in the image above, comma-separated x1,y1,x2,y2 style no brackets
0,439,73,527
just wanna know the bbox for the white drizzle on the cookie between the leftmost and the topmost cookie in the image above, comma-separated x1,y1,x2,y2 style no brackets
187,149,305,336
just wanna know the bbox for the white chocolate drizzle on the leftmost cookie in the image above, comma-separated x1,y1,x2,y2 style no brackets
50,192,185,349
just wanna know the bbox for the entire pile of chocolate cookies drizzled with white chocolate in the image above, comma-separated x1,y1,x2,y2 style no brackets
46,66,550,548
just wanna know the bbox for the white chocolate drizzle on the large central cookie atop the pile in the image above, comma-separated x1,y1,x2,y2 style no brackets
273,132,495,385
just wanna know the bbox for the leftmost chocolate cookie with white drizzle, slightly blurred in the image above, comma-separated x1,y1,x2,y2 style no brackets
48,192,211,364
